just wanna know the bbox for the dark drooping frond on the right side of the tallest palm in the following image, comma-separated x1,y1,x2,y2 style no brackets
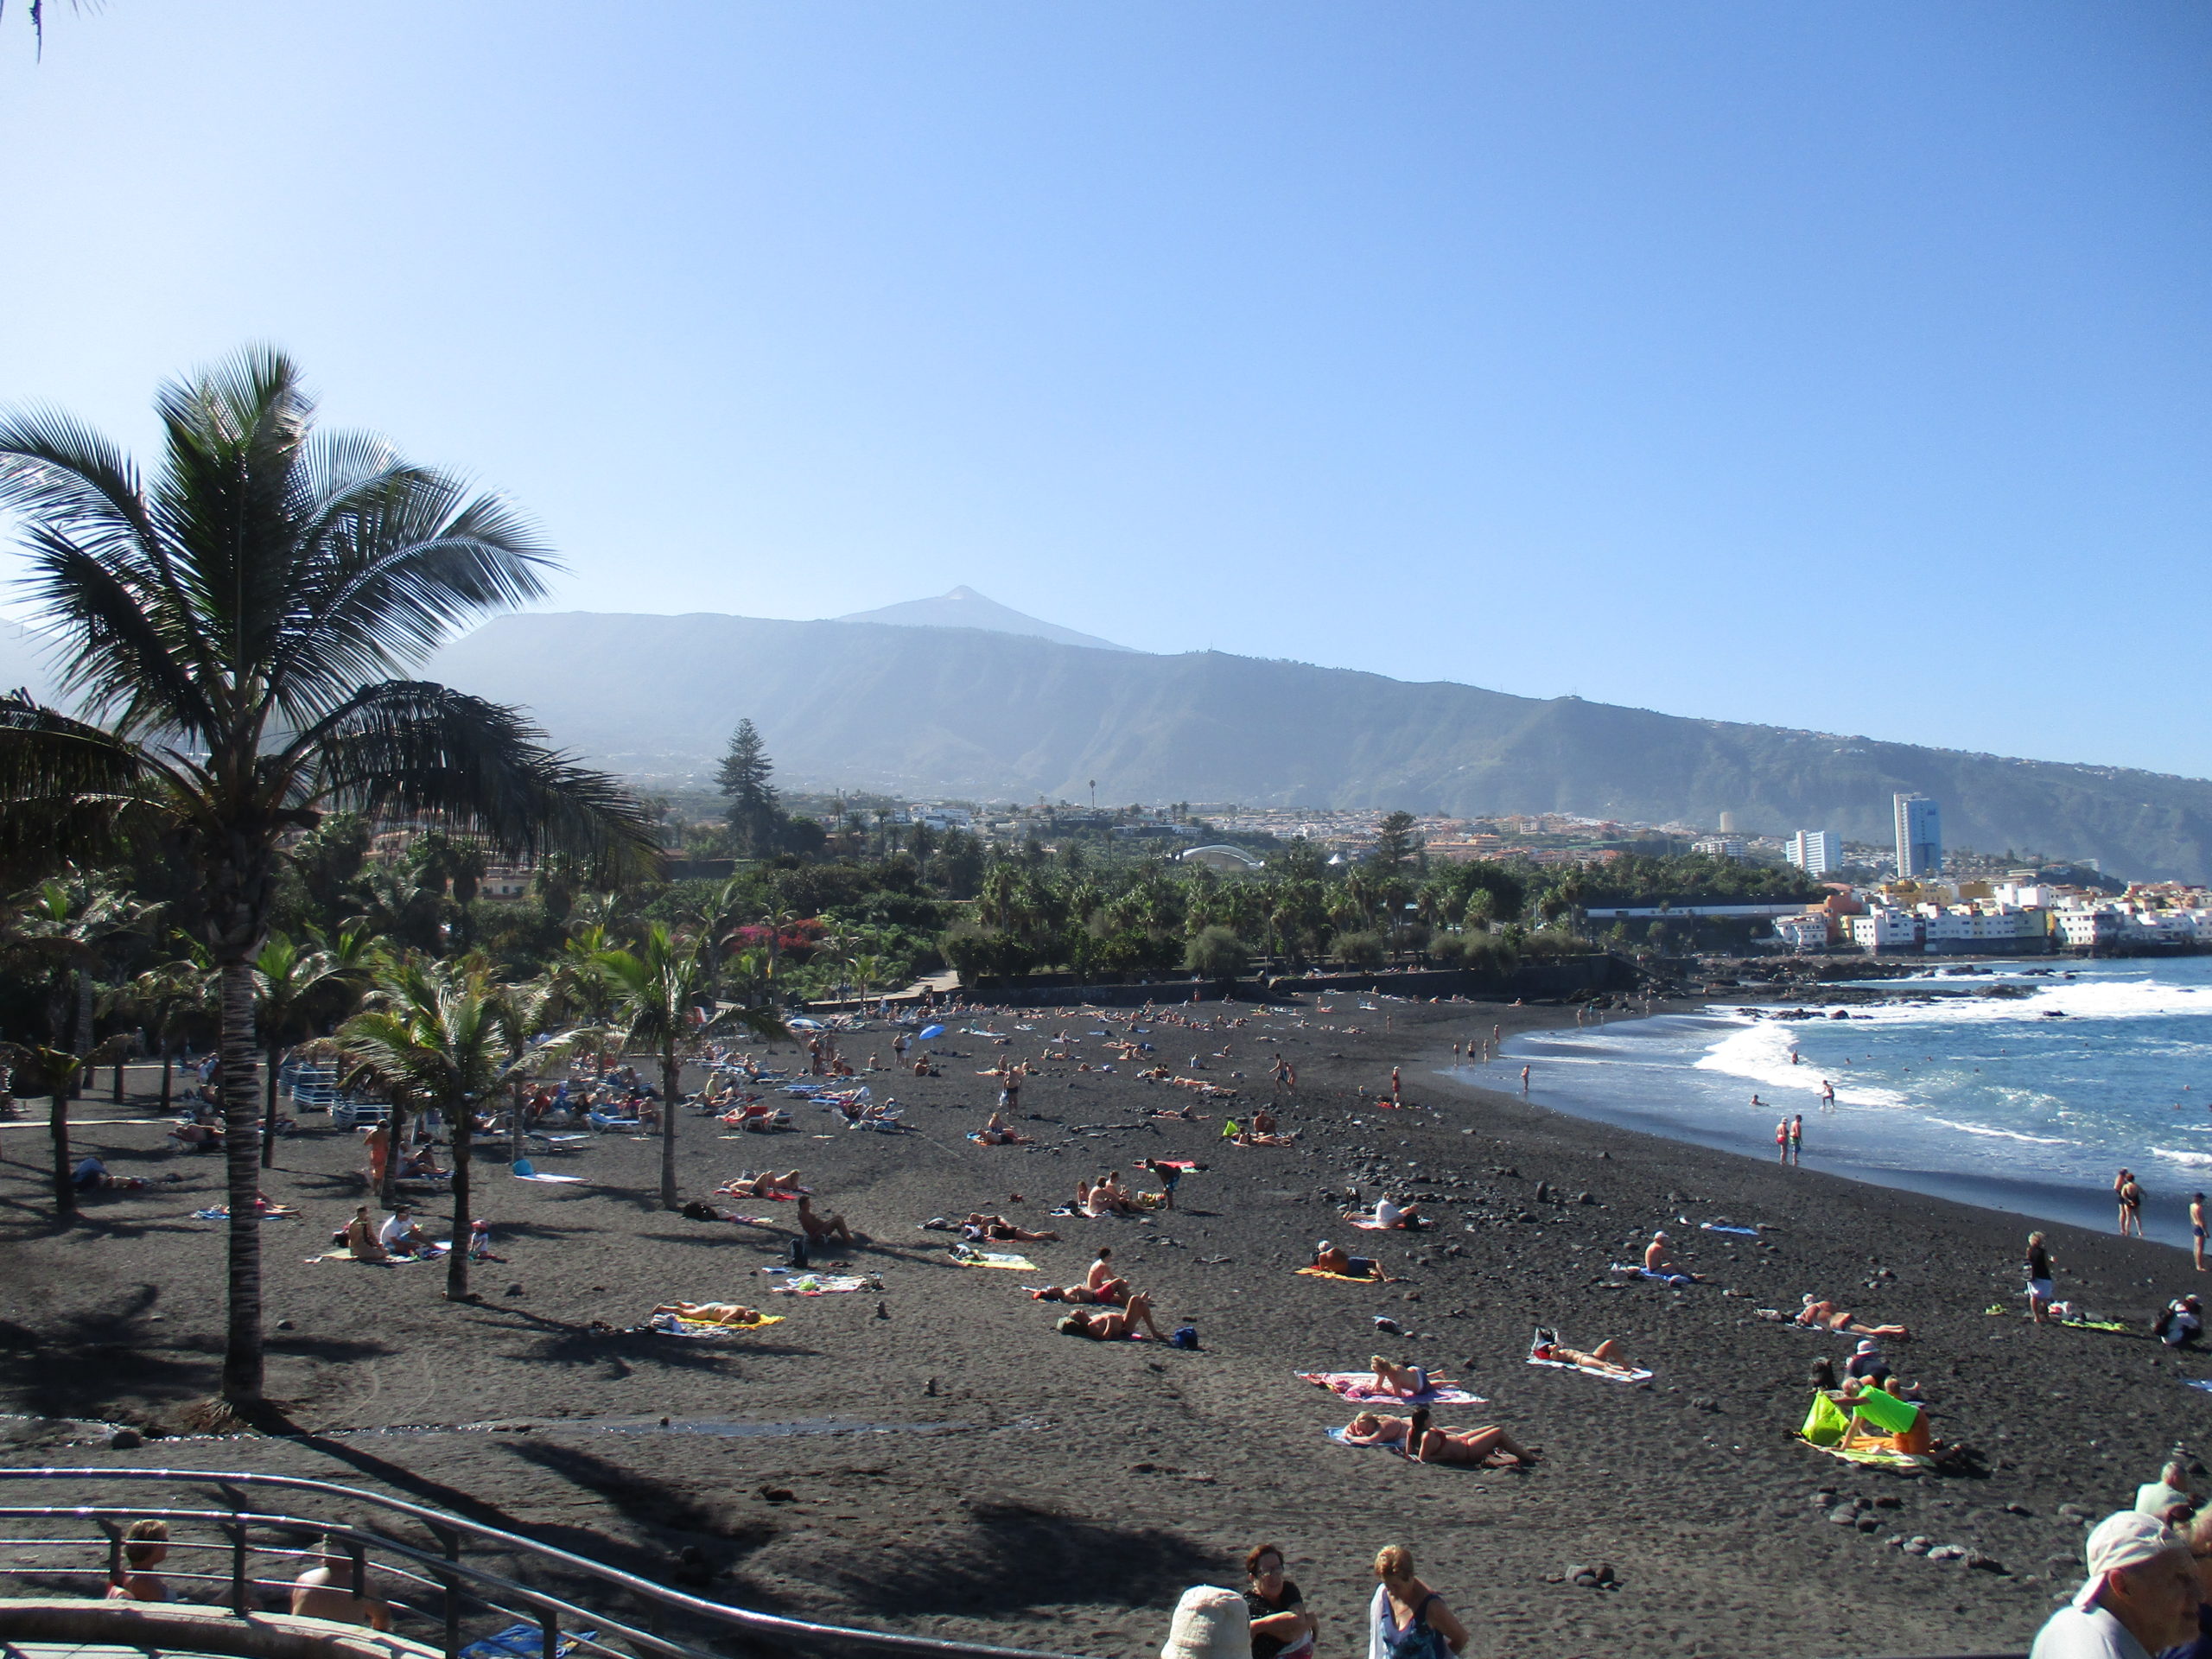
302,679,657,876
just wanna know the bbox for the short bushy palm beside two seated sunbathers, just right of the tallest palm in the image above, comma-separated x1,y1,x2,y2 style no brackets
339,957,566,1303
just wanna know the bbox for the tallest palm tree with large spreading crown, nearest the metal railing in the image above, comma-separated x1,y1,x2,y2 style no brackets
0,352,652,1405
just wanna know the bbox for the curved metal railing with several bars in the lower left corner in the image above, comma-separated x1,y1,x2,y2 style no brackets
0,1469,1068,1659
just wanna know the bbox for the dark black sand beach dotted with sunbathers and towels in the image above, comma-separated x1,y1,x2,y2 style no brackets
0,995,2212,1659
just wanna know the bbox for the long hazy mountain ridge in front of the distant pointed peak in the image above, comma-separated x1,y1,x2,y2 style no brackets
427,613,2212,880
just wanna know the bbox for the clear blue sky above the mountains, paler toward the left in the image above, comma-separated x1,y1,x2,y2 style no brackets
0,0,2212,774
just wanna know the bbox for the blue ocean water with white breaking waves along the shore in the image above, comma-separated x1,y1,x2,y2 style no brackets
1455,957,2212,1245
